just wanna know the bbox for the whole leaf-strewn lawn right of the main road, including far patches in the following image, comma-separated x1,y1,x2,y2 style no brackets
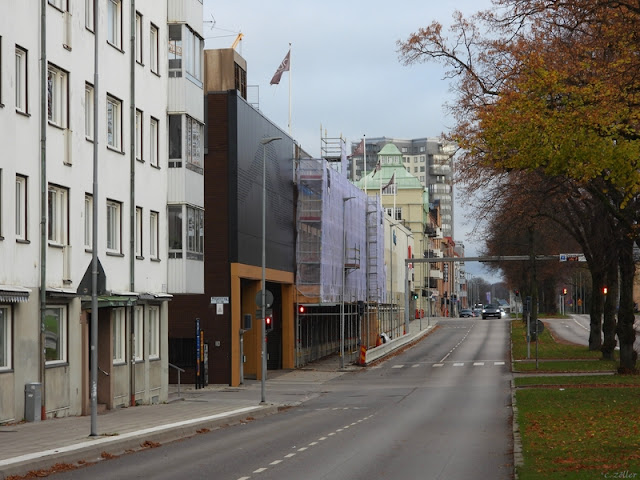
512,321,640,480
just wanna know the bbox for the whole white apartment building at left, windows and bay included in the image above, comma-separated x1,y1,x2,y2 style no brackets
0,0,204,423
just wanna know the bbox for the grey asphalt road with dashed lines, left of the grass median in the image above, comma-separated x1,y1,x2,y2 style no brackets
51,319,513,480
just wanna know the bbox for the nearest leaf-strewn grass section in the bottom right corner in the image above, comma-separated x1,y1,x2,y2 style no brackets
516,388,640,480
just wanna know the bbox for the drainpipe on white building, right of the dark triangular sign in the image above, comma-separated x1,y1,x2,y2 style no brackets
128,0,136,407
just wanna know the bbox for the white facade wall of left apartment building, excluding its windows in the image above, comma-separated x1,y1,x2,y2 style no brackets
0,0,204,423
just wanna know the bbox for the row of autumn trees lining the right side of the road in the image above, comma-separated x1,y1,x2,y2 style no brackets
398,0,640,372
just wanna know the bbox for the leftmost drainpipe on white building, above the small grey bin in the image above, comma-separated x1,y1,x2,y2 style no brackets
40,0,48,420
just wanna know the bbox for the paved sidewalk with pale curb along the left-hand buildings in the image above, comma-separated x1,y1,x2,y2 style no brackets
0,318,437,480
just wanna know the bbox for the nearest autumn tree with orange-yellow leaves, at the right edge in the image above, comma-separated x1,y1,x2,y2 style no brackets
398,0,640,372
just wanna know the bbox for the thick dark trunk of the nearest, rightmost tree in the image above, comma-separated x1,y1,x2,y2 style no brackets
616,238,638,373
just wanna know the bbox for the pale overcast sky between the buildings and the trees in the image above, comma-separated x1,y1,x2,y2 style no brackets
204,0,502,281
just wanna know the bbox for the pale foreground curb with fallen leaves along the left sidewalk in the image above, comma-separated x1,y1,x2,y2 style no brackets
0,405,279,480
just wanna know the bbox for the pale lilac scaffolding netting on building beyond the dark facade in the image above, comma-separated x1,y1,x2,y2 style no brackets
296,159,385,303
